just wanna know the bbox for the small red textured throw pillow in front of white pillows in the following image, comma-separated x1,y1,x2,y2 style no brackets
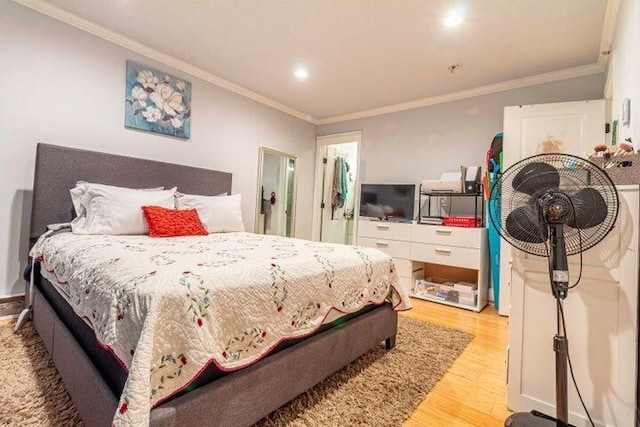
142,206,209,237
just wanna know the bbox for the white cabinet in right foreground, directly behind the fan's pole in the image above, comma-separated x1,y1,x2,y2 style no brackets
507,185,640,427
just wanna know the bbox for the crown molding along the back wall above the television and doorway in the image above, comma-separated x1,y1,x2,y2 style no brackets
318,62,605,125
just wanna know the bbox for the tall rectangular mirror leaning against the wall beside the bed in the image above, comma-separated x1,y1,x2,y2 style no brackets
255,147,297,237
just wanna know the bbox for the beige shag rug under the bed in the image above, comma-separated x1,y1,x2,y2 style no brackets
0,316,472,427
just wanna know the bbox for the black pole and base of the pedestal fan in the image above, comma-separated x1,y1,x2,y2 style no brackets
504,224,575,427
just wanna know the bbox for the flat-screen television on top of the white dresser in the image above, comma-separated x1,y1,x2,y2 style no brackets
360,184,416,221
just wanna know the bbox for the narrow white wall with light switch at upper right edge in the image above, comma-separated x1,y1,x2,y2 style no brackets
608,0,640,150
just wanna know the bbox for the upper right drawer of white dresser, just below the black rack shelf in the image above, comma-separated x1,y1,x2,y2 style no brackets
411,224,487,249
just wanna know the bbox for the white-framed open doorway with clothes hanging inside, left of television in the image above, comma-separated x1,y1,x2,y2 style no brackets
312,131,362,245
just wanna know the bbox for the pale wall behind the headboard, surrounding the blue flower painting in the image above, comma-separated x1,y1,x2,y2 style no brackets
0,0,315,296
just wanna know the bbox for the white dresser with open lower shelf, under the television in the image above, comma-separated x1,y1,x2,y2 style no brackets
357,219,489,311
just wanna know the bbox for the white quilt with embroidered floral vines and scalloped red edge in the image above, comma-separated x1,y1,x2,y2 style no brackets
31,233,410,426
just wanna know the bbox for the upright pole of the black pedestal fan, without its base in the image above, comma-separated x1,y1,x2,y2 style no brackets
549,224,569,427
